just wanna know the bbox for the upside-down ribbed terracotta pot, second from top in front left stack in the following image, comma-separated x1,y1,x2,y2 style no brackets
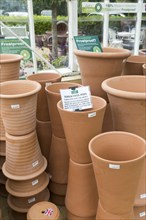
2,131,47,180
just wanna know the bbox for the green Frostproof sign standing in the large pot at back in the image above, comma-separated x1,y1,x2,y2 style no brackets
74,36,102,52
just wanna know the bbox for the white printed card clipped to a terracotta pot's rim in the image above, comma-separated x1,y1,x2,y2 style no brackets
60,86,93,111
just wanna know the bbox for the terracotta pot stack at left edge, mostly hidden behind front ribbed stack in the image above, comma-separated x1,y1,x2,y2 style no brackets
0,54,23,195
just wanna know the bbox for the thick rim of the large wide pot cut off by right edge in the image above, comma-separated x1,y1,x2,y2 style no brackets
101,75,146,100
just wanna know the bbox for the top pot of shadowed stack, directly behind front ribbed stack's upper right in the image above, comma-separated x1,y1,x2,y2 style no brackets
27,73,62,121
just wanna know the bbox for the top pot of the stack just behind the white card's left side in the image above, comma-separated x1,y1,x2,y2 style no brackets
45,82,81,138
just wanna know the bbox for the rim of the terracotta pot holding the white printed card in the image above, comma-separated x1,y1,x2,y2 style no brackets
57,95,107,115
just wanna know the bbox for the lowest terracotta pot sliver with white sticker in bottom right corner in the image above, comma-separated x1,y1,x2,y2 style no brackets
134,205,146,220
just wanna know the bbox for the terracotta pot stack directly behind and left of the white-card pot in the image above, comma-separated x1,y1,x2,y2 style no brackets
46,82,81,205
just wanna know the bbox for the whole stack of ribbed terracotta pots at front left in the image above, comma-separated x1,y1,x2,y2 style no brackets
0,80,50,217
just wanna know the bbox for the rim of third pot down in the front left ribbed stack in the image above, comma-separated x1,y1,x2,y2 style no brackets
5,172,49,197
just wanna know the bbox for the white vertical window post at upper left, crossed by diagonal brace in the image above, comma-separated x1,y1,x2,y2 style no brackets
27,0,37,72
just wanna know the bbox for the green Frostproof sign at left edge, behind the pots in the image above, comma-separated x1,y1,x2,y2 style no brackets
0,38,32,61
